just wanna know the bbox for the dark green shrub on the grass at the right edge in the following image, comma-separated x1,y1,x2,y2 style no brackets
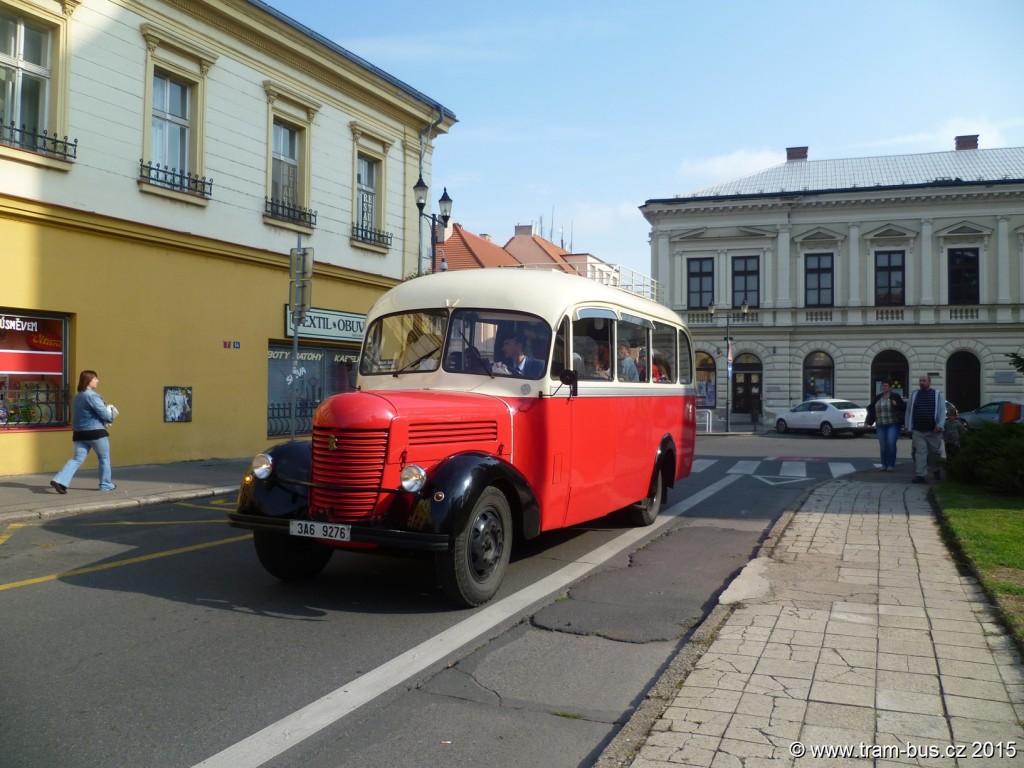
946,422,1024,494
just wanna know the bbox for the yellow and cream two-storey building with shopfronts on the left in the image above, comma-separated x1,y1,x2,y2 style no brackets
0,0,455,474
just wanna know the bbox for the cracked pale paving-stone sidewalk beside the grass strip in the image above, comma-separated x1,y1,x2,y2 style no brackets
603,477,1024,768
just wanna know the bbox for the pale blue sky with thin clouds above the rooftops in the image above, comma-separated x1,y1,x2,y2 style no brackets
267,0,1024,274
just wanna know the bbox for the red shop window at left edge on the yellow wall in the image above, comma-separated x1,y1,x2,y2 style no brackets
0,310,73,429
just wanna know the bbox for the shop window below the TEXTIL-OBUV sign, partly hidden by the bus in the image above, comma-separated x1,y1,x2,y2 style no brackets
266,344,359,437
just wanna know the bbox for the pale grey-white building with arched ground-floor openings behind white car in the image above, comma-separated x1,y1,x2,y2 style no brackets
641,136,1024,424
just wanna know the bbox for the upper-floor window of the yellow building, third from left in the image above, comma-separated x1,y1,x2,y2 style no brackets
263,80,319,231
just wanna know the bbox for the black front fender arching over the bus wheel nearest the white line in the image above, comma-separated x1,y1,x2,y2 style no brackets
414,451,541,539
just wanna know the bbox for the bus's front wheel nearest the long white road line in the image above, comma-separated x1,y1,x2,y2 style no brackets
436,486,512,607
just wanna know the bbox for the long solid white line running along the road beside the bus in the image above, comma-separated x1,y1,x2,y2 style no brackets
195,474,740,768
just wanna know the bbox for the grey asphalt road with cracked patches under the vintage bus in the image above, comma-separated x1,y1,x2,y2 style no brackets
0,435,878,768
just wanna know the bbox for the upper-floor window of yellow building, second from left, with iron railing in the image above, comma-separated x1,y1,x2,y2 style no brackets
138,24,217,205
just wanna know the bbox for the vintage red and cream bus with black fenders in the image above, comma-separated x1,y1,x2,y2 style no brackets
229,268,695,606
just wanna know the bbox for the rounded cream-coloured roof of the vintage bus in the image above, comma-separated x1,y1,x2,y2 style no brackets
368,267,683,328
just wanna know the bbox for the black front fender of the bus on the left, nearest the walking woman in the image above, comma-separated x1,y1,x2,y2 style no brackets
237,440,313,517
